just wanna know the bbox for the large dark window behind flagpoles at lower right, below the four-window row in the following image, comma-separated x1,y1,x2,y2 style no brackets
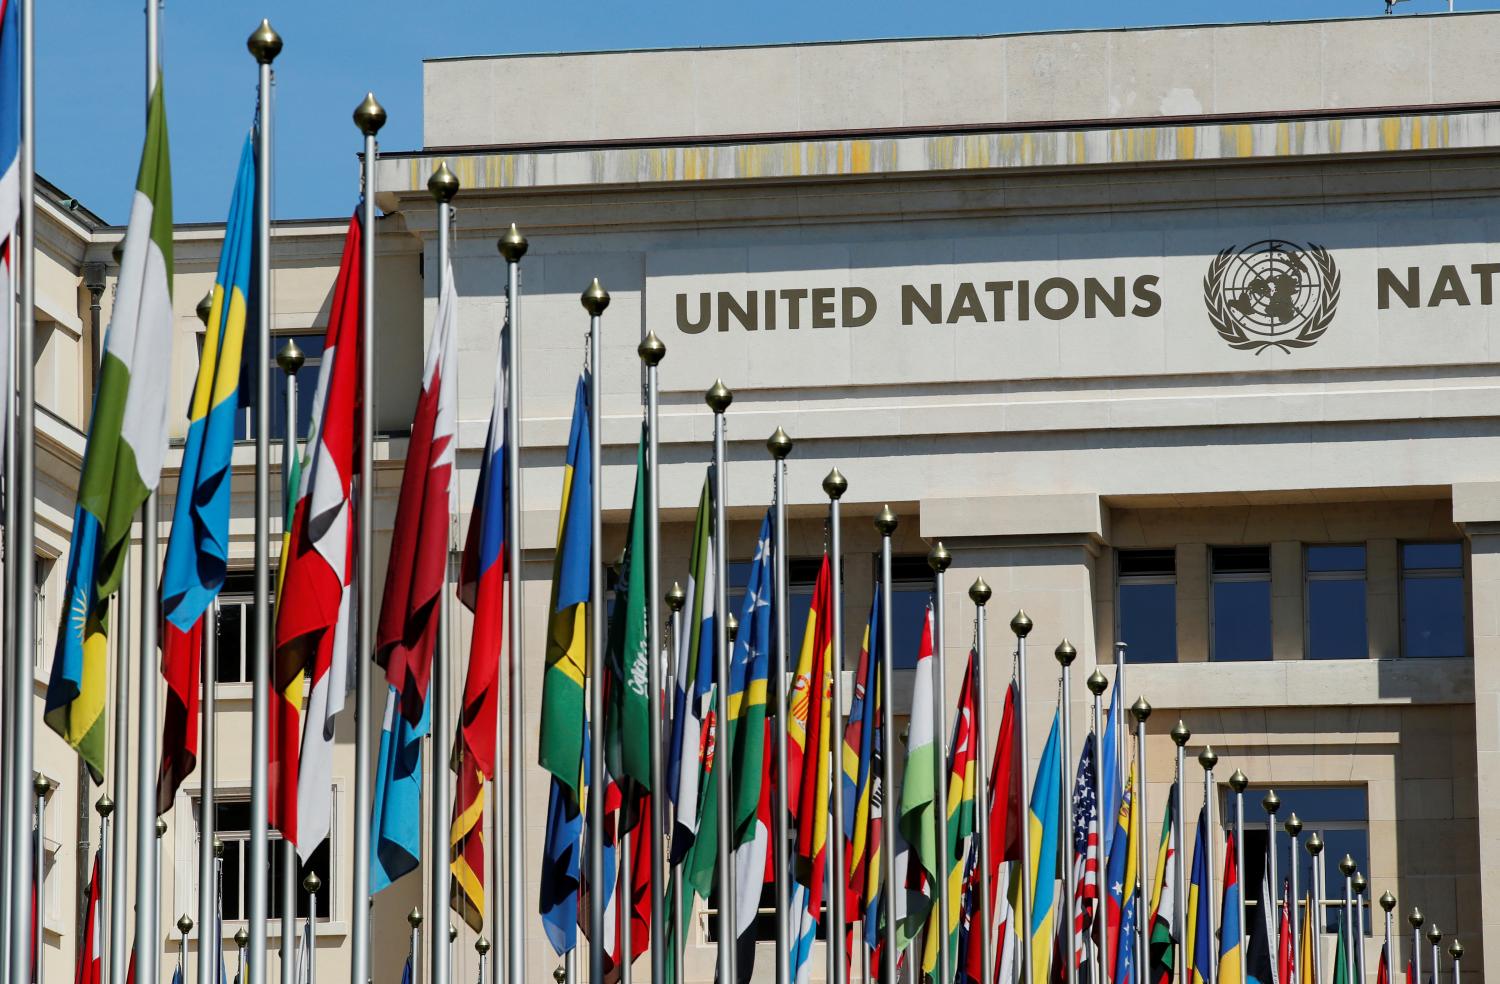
1220,786,1374,933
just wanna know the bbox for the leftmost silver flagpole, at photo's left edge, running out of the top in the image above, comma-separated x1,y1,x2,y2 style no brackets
5,3,36,966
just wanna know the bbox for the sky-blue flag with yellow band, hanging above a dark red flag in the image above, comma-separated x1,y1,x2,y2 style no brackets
162,135,255,632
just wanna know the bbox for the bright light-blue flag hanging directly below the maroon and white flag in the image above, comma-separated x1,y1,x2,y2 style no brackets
371,687,432,894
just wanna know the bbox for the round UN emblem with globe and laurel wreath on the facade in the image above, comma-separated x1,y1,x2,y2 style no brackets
1203,239,1338,356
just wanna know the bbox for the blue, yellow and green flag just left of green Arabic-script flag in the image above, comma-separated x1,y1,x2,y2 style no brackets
537,374,594,797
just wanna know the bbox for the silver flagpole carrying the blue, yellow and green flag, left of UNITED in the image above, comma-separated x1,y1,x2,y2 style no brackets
582,278,612,984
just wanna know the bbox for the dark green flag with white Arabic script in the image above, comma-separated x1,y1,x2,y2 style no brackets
605,428,654,789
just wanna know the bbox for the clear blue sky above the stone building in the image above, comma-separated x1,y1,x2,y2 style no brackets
36,0,1500,222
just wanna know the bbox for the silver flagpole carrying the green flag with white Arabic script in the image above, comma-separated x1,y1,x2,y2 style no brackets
639,332,669,984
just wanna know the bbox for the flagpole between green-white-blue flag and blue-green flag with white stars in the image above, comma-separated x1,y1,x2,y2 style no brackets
705,380,738,981
